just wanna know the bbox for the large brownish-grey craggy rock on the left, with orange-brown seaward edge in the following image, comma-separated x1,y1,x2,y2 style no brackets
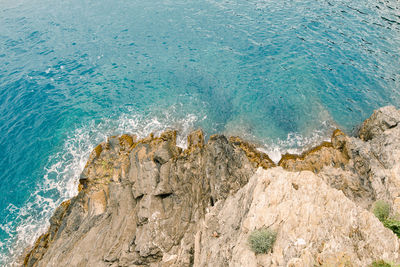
25,131,255,266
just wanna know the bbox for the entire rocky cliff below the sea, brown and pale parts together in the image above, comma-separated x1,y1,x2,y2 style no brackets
24,107,400,266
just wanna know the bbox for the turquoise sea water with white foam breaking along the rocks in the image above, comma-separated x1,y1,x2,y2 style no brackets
0,0,400,265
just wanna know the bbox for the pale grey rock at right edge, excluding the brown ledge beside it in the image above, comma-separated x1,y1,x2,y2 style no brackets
347,106,400,214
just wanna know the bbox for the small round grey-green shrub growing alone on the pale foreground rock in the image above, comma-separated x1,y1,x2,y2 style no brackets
248,228,276,254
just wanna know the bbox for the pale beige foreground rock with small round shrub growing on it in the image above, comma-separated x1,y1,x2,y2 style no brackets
194,167,400,266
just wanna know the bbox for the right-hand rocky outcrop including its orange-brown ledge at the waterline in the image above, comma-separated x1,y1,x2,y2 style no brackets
278,106,400,214
